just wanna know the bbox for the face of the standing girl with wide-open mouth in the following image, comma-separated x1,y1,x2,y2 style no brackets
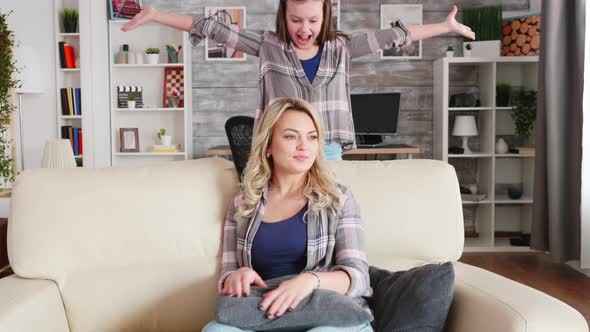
286,0,327,50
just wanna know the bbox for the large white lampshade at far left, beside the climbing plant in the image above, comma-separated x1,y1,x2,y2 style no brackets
14,45,47,93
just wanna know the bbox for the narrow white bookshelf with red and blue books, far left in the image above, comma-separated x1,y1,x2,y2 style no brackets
53,0,85,167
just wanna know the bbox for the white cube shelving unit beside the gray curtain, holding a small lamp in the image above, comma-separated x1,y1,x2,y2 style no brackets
433,56,539,251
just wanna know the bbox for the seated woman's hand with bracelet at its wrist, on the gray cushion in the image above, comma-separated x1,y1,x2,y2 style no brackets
260,273,317,319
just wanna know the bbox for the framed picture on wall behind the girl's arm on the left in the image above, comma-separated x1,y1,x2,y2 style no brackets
205,7,246,61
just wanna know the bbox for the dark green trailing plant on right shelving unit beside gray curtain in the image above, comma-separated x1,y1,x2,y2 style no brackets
510,90,537,145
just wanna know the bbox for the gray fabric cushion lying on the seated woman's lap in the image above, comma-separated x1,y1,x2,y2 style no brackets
216,275,373,331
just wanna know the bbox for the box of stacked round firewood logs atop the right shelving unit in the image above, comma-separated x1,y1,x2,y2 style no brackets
502,16,541,56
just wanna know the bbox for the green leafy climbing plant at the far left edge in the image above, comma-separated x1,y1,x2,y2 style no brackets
0,11,19,191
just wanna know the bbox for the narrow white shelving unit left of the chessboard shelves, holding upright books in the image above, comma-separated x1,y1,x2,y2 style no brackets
53,0,85,166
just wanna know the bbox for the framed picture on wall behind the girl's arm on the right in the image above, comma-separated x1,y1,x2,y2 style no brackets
381,5,422,59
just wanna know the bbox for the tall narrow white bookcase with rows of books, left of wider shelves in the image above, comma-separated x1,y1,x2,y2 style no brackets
54,0,87,166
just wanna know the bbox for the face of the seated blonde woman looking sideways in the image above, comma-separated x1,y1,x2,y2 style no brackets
267,110,319,174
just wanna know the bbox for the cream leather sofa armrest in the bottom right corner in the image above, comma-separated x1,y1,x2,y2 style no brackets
447,263,588,332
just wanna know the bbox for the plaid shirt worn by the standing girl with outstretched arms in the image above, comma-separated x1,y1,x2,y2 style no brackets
190,16,412,149
